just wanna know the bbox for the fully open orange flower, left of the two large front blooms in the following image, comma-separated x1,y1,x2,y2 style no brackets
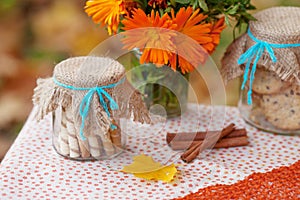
122,9,176,65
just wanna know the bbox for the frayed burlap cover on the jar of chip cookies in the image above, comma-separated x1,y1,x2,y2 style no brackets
221,7,300,84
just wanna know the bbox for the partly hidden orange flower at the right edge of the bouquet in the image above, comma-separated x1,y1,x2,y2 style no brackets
202,17,226,54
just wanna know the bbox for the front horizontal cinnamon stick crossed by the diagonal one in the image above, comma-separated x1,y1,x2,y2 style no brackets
170,135,248,150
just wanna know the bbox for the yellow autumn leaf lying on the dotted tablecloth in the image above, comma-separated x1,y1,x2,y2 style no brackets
121,154,177,182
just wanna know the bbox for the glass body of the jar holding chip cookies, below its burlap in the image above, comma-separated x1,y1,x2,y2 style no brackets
238,68,300,134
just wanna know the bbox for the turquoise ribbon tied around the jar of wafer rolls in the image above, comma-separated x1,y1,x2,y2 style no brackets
53,77,125,140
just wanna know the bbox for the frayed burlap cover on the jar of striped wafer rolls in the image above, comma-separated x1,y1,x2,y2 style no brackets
33,56,150,136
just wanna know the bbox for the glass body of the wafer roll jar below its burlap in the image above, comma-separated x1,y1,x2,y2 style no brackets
52,107,126,160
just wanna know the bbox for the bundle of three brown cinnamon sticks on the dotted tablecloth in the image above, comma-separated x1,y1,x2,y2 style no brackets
166,123,248,163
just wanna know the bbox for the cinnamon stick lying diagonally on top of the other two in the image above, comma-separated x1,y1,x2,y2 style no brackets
181,123,235,163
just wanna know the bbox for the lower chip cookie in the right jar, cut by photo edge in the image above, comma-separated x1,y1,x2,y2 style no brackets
260,86,300,130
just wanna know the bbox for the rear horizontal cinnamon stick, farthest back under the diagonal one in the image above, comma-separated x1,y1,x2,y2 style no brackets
166,128,247,144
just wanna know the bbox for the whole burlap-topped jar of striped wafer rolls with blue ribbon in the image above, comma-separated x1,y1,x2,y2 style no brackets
33,56,150,160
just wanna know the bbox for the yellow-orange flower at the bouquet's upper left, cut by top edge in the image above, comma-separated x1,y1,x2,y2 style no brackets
85,0,126,35
